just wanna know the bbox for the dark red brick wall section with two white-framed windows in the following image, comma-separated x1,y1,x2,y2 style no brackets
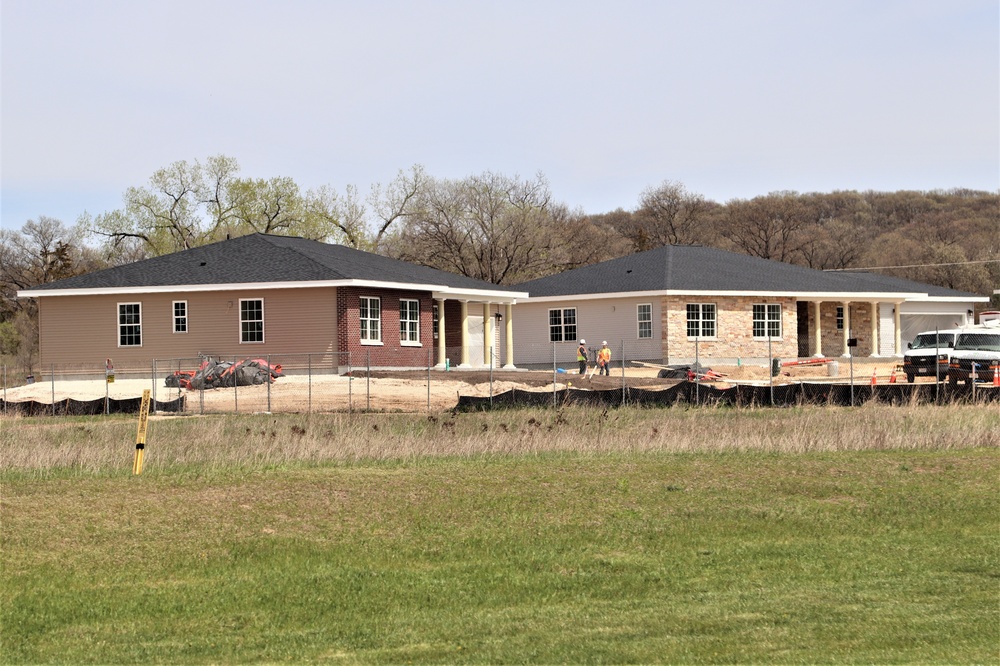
337,287,436,368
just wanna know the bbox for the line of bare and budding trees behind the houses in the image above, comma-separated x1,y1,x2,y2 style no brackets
0,155,1000,374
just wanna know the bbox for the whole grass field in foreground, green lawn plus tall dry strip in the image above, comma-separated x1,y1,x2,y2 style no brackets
0,407,1000,664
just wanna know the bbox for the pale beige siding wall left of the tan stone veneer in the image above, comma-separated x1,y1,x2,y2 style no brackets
513,297,663,366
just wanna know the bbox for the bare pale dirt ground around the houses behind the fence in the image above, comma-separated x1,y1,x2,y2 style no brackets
2,360,905,413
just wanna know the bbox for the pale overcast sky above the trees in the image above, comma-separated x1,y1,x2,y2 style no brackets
0,0,1000,228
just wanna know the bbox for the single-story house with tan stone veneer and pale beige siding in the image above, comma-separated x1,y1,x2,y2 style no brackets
514,245,989,367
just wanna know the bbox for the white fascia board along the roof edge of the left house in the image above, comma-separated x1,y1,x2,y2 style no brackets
17,280,527,302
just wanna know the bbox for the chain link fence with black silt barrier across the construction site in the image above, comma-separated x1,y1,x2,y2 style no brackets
0,339,1000,415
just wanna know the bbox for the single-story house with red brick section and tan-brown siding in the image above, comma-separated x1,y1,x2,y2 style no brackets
18,234,527,371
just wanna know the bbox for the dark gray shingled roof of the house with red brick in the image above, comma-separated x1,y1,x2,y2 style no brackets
29,234,515,291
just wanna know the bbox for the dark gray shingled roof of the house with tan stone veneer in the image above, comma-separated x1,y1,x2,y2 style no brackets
513,245,975,297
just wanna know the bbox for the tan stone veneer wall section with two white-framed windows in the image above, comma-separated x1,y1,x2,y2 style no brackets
660,296,798,360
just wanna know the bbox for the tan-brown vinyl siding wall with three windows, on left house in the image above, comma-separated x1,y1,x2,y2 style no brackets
38,287,337,367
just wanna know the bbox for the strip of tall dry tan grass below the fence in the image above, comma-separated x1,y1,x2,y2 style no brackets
0,404,1000,475
